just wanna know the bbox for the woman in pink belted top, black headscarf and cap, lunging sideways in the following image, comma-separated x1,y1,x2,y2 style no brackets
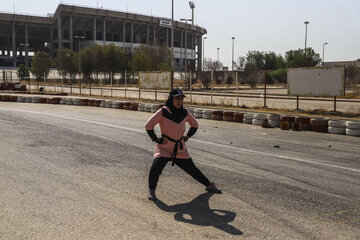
145,89,221,201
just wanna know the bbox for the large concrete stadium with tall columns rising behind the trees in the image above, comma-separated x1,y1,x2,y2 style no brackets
0,4,207,71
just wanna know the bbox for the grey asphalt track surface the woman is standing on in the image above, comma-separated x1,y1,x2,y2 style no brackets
0,102,360,240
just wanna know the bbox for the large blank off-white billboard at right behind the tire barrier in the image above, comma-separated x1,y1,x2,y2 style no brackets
287,66,345,97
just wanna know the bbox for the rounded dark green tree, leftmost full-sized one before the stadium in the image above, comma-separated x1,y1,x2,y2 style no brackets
31,51,52,80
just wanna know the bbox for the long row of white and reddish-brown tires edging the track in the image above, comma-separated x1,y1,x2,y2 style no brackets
0,95,360,136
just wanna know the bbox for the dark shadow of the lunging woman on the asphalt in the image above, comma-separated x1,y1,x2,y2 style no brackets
155,193,243,235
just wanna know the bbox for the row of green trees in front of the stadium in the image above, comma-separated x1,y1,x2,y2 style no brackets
18,44,172,84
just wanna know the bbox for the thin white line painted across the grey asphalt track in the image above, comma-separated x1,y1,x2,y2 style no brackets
0,108,360,172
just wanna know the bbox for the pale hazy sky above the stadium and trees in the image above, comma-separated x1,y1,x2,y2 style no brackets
0,0,360,66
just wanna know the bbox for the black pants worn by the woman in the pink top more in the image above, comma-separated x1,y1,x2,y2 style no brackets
149,157,211,190
